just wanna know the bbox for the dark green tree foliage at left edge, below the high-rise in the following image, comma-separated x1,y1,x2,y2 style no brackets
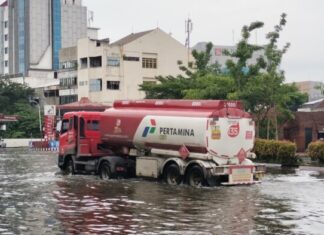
0,79,41,138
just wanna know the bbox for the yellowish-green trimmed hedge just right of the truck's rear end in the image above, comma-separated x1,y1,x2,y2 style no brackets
253,139,298,166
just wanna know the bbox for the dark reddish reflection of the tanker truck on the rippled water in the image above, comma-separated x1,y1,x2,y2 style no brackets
54,179,255,234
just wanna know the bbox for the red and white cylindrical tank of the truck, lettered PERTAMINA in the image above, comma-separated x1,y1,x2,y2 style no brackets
101,100,254,162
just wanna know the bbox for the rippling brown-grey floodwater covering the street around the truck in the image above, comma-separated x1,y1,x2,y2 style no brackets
0,149,324,235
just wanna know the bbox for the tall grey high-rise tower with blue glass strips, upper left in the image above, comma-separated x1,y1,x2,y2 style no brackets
0,0,87,78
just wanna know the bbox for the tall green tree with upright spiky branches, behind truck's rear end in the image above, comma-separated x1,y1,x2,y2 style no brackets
226,13,305,139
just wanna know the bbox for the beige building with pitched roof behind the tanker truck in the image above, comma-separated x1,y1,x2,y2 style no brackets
77,28,188,104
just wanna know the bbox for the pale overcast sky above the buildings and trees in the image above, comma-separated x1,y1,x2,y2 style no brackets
83,0,324,82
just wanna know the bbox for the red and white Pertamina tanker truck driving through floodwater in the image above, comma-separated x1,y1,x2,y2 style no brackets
58,100,265,187
